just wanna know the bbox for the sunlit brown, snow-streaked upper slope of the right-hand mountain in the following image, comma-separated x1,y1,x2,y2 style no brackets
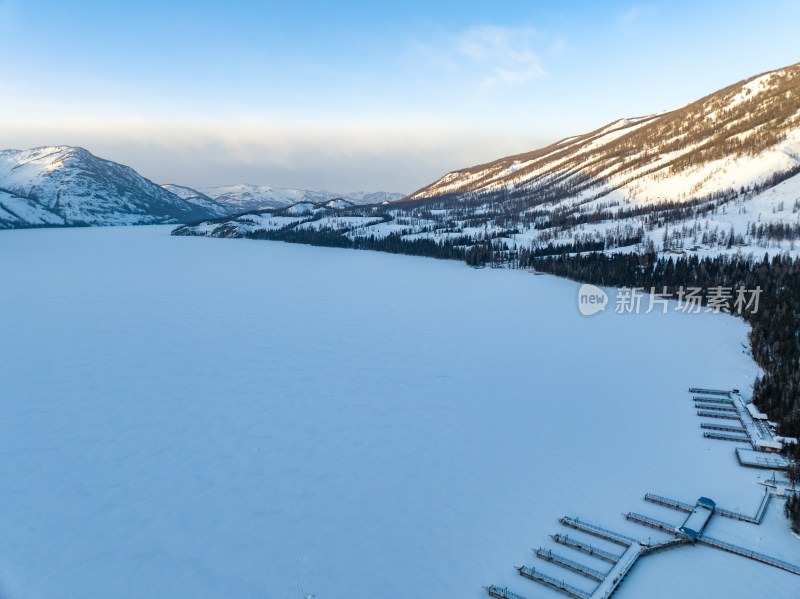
408,64,800,205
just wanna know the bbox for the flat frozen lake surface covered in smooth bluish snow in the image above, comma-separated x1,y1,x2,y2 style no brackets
0,227,800,599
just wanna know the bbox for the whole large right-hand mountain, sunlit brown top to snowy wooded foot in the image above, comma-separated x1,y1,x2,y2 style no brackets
178,63,800,260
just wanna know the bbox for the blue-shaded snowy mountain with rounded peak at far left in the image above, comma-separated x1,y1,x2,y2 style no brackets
0,146,220,228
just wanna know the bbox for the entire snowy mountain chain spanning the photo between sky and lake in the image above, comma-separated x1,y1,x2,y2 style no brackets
0,64,800,254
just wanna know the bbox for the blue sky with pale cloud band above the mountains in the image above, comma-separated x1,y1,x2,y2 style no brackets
0,0,800,192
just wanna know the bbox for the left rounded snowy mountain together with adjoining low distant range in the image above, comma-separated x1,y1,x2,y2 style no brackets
0,146,403,229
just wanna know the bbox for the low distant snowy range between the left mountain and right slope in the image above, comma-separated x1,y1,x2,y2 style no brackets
198,184,405,214
